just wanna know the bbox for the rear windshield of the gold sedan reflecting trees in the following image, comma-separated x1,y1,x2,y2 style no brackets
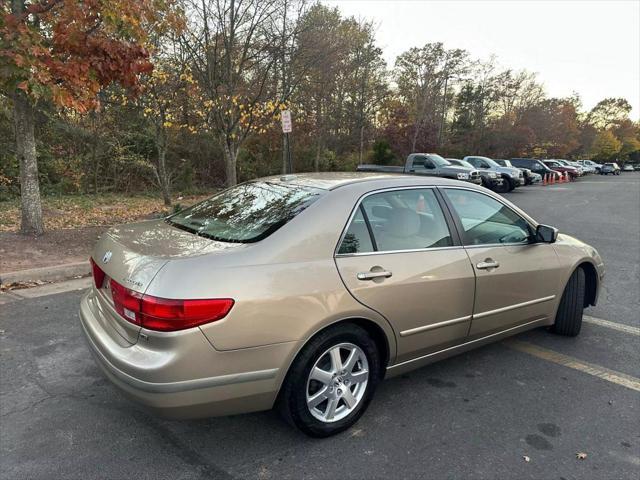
167,182,324,243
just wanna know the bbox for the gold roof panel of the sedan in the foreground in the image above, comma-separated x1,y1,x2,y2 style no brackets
257,172,472,190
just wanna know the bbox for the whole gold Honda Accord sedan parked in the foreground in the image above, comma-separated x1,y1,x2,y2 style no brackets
80,173,604,437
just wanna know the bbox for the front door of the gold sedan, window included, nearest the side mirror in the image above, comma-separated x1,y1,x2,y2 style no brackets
442,187,561,337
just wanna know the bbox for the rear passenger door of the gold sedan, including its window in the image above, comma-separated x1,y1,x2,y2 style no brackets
335,188,475,361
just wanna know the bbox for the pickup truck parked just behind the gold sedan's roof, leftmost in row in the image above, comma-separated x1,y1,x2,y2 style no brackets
356,153,482,185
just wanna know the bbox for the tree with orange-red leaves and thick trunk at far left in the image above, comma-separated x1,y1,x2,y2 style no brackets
0,0,181,235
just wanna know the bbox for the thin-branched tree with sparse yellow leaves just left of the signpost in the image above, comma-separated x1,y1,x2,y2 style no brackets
182,0,284,186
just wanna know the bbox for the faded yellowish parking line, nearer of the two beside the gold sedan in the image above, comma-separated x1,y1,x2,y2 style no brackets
503,340,640,392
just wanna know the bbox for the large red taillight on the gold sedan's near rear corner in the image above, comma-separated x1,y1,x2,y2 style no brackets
111,280,233,332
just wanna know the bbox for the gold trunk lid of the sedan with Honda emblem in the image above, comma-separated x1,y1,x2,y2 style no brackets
92,220,245,346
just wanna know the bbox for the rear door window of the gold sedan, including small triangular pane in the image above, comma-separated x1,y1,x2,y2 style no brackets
338,189,453,253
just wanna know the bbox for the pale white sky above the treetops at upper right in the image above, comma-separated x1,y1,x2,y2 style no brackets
323,0,640,120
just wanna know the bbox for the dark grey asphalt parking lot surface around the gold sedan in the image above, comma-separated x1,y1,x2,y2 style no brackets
0,173,640,480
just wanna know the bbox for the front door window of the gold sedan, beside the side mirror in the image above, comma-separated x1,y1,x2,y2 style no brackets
444,189,532,245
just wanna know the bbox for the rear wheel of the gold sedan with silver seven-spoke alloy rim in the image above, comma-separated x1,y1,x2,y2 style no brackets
277,323,381,438
